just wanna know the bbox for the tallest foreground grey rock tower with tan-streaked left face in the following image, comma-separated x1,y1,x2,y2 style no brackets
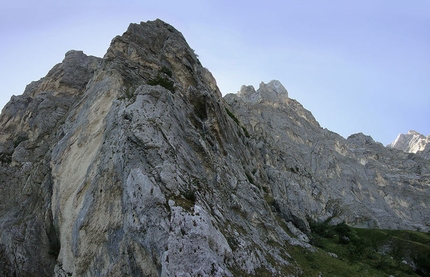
47,21,294,276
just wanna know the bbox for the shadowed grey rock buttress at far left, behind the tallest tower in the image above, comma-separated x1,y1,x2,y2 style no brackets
0,49,99,276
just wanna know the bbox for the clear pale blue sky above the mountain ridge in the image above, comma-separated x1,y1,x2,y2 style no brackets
0,0,430,145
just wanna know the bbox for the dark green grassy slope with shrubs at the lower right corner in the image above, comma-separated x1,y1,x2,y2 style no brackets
294,222,430,276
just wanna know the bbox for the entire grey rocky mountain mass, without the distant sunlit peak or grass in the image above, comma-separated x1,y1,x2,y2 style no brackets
0,20,430,276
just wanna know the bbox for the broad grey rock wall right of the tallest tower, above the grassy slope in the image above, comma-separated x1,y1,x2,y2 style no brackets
225,81,430,231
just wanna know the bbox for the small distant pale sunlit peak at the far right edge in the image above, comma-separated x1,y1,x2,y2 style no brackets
387,130,430,160
